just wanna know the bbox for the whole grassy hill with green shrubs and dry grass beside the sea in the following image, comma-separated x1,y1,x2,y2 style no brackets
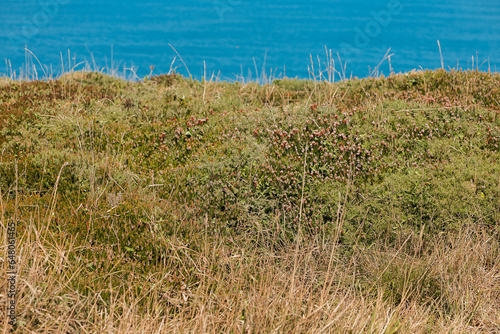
0,70,500,333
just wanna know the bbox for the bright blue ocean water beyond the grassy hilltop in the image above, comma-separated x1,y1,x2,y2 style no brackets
0,0,500,80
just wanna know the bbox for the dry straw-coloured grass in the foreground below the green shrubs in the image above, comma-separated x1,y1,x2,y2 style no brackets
1,194,500,333
